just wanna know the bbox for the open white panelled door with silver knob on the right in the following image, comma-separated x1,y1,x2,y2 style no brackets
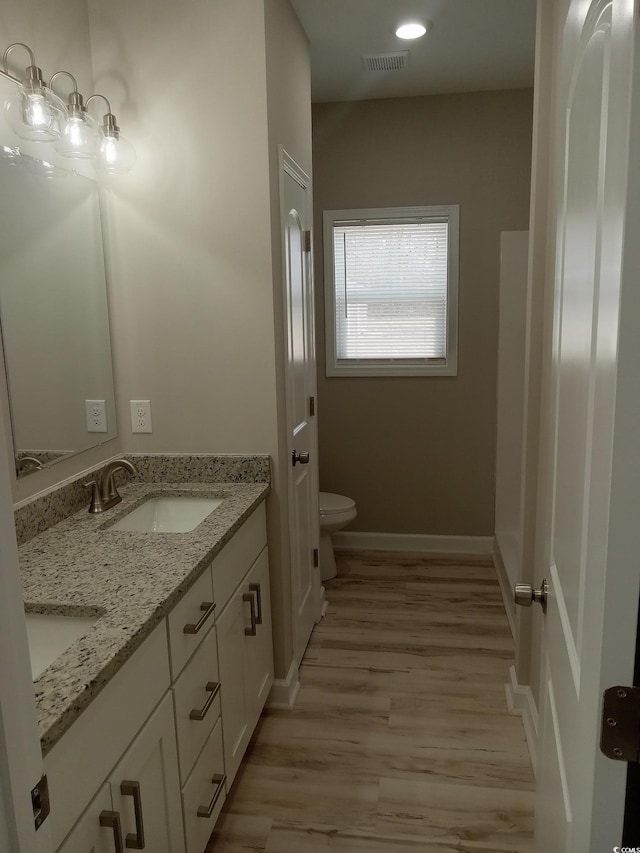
535,0,640,853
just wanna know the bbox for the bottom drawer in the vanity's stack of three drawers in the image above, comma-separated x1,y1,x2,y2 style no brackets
182,720,227,853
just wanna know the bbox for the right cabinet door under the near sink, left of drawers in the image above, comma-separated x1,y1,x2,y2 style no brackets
109,694,184,853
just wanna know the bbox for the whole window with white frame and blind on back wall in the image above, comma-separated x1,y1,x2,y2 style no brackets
324,205,459,376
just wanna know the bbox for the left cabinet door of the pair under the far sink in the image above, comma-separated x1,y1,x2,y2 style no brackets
216,583,252,787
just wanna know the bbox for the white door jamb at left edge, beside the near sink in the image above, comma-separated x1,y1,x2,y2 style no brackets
0,412,52,853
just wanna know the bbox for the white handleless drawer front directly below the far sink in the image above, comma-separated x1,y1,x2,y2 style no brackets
211,503,267,614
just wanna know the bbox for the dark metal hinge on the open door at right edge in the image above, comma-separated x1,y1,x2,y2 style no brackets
600,685,640,762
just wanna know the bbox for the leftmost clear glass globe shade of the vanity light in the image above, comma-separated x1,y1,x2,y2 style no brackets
4,85,67,142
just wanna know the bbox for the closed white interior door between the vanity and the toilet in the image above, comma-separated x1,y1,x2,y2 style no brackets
280,150,320,662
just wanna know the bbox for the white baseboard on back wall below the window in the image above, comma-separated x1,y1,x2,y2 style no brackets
331,530,493,554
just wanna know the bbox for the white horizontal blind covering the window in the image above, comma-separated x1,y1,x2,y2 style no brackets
333,219,449,362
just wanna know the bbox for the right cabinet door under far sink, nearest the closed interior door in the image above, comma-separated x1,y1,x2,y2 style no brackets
243,548,273,731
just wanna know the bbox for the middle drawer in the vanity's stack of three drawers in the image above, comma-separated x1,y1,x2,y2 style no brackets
173,628,220,784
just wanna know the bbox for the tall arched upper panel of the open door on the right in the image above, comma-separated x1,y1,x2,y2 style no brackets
553,7,611,664
